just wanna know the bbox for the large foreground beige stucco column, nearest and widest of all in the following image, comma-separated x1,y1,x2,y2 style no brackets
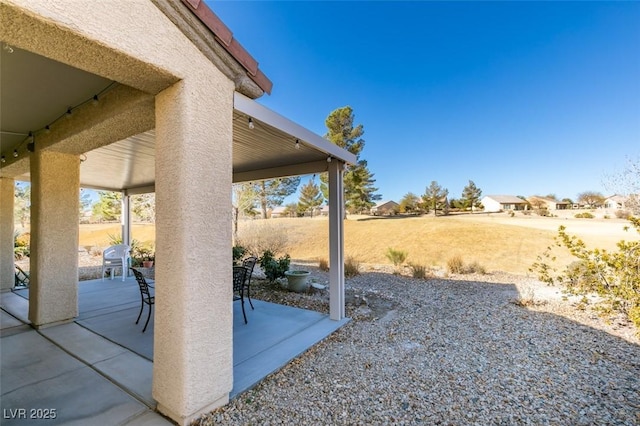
153,75,233,424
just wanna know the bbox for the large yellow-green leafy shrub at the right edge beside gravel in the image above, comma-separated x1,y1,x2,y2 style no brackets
529,217,640,328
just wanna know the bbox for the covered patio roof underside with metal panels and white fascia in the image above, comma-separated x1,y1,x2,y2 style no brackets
0,44,356,194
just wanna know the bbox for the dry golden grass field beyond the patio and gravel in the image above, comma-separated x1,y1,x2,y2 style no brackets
74,214,639,274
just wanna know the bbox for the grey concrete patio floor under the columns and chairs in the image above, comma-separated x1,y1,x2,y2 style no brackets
0,278,348,425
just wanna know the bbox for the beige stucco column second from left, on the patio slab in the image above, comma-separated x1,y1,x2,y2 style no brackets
29,149,80,327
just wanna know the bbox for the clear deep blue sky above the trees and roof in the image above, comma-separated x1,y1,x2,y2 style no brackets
207,0,640,201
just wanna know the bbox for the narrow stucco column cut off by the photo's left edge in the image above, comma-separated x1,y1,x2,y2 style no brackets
0,178,15,291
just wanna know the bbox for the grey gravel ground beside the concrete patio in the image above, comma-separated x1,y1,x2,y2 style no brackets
194,265,640,425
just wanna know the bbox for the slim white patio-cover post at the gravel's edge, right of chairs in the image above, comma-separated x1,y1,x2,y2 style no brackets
329,160,345,321
